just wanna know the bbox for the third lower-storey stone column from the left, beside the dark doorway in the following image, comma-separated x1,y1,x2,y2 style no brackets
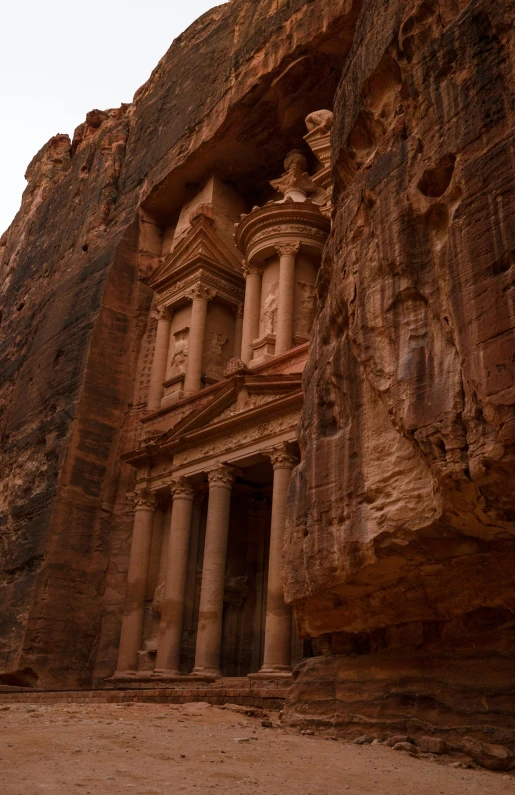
193,464,236,676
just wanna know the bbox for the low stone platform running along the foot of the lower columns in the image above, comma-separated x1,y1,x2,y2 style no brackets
0,677,289,709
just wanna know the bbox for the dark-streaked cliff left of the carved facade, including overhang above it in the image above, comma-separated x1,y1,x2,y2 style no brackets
0,0,359,686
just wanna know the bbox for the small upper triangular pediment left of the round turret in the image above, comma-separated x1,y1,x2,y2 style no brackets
149,216,243,291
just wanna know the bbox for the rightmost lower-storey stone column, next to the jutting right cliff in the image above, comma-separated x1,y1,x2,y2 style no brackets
260,444,298,675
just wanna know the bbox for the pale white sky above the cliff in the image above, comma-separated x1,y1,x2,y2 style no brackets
0,0,224,235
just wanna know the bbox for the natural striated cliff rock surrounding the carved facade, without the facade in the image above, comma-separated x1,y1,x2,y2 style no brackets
0,0,515,760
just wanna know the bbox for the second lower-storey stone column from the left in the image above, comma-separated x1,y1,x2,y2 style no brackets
154,478,195,676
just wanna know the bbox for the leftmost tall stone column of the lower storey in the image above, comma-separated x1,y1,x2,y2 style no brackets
115,489,157,676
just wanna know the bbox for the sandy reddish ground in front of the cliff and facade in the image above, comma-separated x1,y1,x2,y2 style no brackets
0,704,515,795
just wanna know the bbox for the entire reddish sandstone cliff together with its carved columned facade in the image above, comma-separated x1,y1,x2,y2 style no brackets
0,0,515,767
